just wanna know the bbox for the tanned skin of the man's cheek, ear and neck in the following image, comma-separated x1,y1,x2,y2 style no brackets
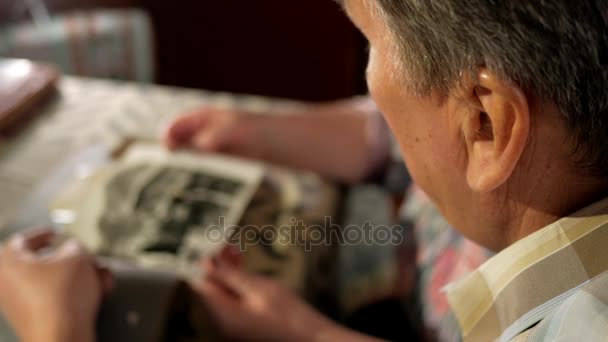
346,0,604,250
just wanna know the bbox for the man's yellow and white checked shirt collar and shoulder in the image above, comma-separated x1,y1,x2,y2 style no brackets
446,198,608,341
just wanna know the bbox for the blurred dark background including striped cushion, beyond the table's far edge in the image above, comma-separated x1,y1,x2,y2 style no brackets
0,0,366,101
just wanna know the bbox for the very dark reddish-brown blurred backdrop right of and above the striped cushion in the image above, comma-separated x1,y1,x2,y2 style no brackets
0,0,366,101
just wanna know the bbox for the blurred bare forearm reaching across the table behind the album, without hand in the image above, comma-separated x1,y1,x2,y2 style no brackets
256,99,389,183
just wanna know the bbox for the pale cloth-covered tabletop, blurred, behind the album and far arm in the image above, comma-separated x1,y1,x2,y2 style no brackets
0,77,301,227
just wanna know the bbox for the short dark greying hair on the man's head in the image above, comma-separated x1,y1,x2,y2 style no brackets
371,0,608,177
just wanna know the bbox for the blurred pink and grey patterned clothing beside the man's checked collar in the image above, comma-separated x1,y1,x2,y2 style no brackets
401,185,492,341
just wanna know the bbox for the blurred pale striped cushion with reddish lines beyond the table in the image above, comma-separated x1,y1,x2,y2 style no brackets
0,9,154,82
